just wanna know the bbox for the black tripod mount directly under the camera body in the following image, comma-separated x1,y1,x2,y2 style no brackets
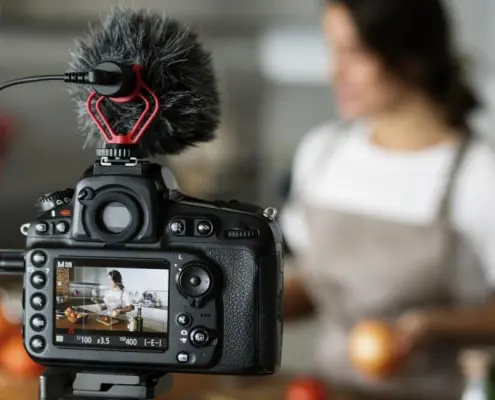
38,368,172,400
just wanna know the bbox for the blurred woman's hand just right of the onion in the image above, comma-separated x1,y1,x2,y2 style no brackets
396,310,433,357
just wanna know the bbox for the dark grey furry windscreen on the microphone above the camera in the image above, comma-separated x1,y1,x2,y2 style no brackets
69,8,220,156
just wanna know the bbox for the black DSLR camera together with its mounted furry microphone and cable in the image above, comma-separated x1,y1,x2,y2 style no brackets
0,11,283,375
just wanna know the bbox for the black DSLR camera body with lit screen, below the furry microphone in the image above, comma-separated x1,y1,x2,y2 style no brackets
23,160,283,375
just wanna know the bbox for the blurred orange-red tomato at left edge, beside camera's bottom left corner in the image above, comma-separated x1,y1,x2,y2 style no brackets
0,335,43,377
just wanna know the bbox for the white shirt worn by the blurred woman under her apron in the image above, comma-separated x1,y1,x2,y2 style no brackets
280,124,495,285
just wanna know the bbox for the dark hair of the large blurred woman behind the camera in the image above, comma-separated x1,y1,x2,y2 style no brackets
326,0,480,133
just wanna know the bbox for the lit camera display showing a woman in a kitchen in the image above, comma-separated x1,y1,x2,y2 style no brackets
54,259,169,351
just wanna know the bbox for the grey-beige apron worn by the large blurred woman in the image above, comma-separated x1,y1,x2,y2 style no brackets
296,134,488,400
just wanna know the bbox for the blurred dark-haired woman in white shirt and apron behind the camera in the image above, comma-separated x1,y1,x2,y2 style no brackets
281,0,495,400
